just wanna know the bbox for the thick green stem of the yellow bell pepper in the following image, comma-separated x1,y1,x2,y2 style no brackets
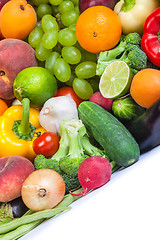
18,98,30,135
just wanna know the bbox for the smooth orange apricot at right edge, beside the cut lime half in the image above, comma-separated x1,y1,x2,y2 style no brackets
130,68,160,108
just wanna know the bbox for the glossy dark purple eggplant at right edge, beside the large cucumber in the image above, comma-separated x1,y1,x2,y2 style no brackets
126,100,160,153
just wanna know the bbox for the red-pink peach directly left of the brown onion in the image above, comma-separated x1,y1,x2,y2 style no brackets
0,156,35,202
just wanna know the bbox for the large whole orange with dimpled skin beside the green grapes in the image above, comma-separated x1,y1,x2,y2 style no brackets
76,6,122,53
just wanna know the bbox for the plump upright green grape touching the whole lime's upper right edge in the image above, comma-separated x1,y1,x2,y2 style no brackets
53,58,71,82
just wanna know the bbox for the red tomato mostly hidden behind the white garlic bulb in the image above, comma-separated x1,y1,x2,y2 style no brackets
55,87,83,108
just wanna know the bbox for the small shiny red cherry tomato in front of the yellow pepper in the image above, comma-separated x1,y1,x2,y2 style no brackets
33,132,59,158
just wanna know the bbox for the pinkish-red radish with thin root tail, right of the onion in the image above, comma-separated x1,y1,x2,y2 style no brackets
70,156,112,196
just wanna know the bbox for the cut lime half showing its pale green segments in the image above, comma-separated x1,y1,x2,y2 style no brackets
99,61,133,98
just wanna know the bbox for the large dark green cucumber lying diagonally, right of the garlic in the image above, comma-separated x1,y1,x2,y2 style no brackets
78,101,140,167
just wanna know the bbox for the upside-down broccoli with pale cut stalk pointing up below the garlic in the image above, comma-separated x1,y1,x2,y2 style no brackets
34,119,104,193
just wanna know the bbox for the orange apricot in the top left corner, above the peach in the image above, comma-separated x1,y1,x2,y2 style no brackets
0,0,37,40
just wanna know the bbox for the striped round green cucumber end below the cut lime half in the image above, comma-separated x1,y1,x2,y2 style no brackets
112,96,145,121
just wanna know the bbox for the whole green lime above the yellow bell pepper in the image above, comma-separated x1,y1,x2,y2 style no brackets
13,67,57,107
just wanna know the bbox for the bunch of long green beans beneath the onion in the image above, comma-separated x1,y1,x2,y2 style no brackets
0,189,82,240
